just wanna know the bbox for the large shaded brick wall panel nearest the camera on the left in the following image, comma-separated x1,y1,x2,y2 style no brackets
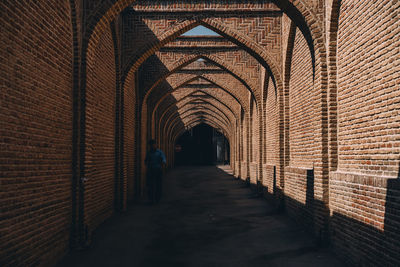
0,0,73,266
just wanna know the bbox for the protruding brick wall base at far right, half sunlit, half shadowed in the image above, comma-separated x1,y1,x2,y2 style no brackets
329,171,400,266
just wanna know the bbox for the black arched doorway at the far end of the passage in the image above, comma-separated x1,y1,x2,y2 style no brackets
175,124,230,166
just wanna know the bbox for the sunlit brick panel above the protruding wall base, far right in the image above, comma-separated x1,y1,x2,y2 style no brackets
337,1,400,177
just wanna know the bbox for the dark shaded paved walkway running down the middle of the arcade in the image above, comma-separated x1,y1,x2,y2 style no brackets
59,167,343,267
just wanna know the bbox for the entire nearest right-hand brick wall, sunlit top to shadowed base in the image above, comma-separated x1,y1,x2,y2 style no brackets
329,1,400,266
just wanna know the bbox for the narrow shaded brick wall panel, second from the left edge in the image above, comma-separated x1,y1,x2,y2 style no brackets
85,25,116,233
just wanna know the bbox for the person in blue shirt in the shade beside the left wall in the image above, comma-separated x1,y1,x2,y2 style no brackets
145,139,167,203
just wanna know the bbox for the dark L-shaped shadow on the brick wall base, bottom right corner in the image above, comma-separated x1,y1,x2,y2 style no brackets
331,178,400,266
